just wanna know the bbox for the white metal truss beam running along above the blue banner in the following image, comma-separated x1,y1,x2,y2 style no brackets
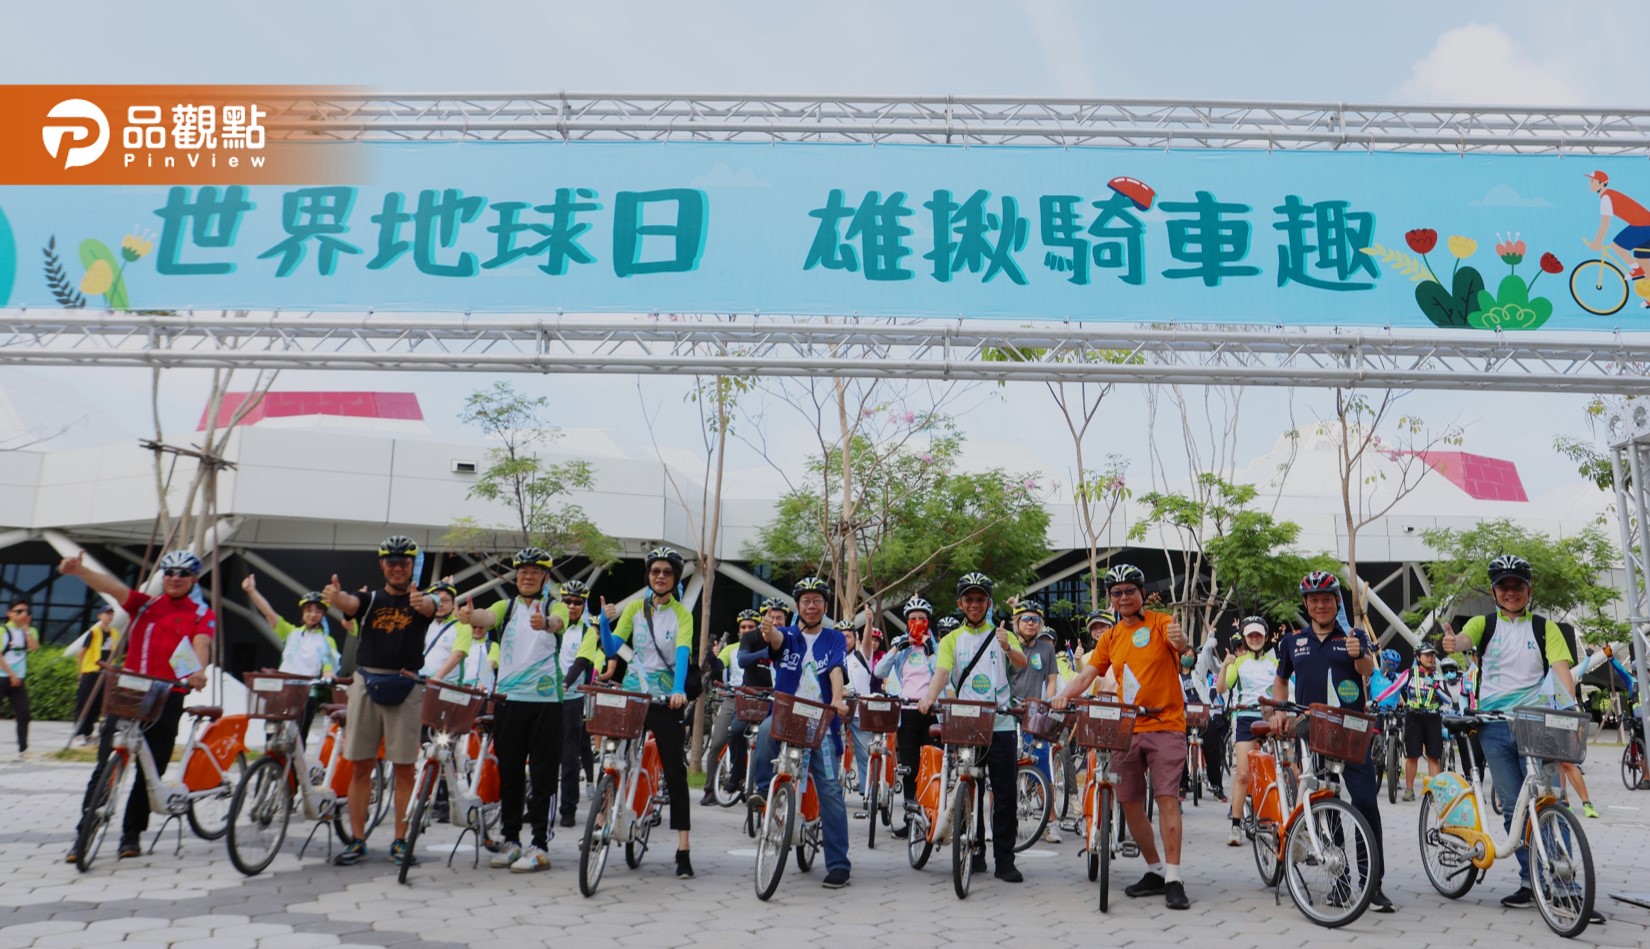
247,92,1650,155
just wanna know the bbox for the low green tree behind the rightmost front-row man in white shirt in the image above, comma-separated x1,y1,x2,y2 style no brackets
1406,518,1627,642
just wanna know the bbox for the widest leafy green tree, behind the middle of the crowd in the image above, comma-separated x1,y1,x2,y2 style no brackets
746,436,1049,619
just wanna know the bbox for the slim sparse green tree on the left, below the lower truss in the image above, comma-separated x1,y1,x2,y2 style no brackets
444,381,619,566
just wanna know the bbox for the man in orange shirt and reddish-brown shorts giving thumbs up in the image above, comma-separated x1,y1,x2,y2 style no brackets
1054,563,1191,909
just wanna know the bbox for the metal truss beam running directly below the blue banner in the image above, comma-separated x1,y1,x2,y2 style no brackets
0,310,1650,394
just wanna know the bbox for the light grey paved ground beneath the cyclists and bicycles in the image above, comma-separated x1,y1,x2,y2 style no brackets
0,725,1650,949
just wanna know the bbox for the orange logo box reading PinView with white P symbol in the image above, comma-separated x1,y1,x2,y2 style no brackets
0,86,365,185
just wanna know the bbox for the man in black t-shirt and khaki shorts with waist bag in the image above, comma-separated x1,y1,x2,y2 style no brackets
322,535,436,866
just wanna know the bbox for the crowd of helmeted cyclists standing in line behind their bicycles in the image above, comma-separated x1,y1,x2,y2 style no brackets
51,535,1623,921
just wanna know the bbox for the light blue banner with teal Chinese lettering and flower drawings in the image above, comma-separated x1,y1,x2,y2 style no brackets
0,142,1650,330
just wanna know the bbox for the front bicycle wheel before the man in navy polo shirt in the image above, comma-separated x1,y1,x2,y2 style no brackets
1284,797,1381,929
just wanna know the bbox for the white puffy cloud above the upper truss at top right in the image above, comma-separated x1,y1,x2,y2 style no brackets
1393,23,1591,106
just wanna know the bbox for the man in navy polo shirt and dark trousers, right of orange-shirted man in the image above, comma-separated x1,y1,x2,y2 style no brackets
1272,569,1396,913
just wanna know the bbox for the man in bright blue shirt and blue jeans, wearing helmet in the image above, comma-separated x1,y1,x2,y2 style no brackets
752,576,853,890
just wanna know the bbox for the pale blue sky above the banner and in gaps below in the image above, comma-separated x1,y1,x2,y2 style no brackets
0,0,1643,497
